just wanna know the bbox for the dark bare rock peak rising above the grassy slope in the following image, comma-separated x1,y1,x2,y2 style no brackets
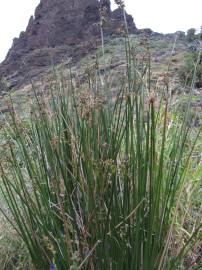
0,0,137,90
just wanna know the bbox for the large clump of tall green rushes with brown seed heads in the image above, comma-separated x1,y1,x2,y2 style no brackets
0,1,201,270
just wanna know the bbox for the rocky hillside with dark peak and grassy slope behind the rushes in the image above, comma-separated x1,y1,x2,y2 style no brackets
0,0,202,115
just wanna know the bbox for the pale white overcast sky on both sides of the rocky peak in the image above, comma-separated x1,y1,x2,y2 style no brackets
0,0,202,62
